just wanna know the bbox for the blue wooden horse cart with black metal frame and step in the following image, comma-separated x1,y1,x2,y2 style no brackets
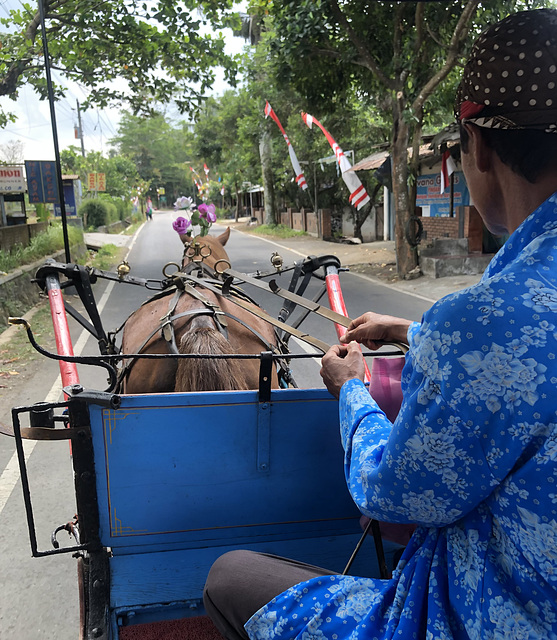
8,255,400,640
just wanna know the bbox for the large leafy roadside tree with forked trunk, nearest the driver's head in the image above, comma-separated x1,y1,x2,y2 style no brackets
271,0,547,276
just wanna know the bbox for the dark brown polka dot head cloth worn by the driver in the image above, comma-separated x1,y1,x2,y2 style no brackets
455,9,557,133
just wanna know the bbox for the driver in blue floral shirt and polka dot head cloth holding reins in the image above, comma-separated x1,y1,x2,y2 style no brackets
205,9,557,640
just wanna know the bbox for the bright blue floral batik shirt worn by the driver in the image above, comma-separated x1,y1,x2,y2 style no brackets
246,194,557,640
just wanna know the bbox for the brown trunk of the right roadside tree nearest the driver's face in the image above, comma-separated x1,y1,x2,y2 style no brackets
392,100,418,278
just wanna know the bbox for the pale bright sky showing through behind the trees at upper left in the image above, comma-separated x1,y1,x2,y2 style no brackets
0,5,244,160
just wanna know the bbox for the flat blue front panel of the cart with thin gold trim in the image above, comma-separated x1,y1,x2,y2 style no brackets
91,390,358,555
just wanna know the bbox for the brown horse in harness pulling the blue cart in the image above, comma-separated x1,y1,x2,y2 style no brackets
122,228,278,393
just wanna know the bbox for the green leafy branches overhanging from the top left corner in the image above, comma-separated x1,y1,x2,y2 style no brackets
0,0,239,124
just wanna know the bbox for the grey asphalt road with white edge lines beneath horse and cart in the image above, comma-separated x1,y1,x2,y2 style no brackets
0,213,430,640
